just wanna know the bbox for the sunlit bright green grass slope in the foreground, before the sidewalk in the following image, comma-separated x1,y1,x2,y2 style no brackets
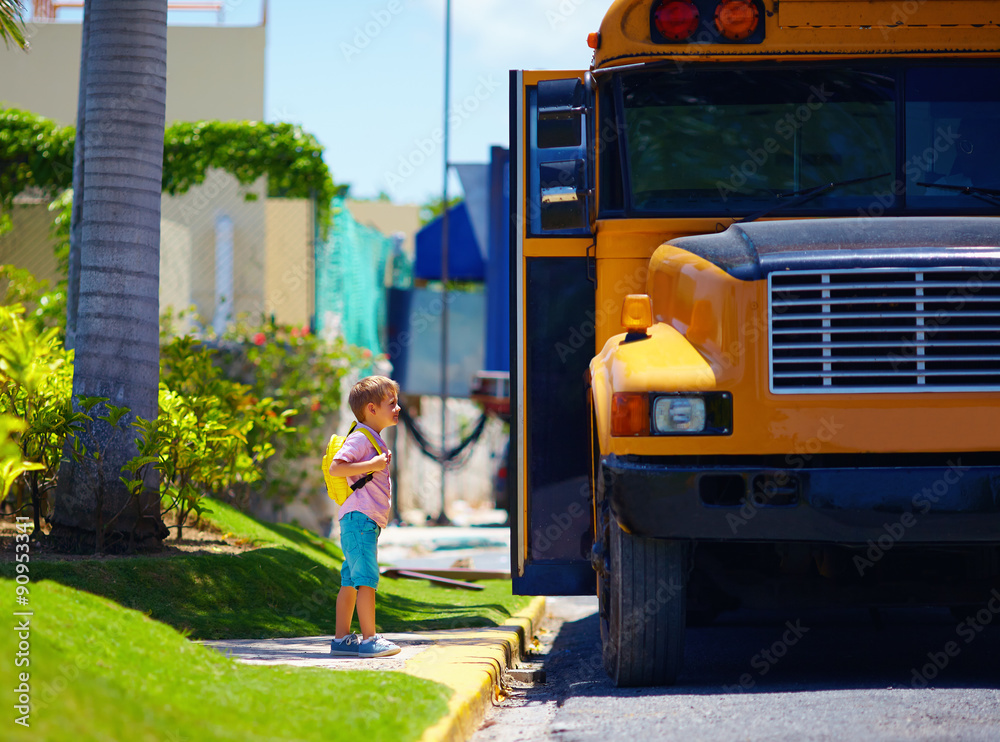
0,579,450,742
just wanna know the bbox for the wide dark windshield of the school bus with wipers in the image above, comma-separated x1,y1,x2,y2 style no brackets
615,64,1000,217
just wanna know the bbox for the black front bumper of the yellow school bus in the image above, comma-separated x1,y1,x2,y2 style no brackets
602,454,1000,544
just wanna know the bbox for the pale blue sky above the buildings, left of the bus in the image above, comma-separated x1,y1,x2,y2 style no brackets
45,0,610,203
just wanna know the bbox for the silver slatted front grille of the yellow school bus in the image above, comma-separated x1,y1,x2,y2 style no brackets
768,267,1000,394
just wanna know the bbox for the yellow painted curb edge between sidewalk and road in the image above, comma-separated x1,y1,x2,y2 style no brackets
405,596,545,742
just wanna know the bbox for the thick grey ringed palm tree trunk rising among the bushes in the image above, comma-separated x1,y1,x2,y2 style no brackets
52,0,167,550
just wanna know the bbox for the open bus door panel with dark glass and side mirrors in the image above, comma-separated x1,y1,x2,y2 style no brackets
510,71,596,595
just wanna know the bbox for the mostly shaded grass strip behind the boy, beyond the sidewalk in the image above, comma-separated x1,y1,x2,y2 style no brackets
13,501,530,639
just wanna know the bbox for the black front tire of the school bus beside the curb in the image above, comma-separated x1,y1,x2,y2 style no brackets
601,519,686,688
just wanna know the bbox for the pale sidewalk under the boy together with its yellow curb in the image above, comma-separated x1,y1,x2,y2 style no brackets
200,597,545,742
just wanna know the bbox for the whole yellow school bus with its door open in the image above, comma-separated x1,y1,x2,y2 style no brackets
510,0,1000,685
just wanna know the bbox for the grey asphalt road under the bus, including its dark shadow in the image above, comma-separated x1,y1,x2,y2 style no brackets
473,598,1000,742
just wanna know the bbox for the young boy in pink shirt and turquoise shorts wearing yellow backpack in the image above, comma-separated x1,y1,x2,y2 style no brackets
330,376,399,657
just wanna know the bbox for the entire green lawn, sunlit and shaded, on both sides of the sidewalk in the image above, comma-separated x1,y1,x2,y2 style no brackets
0,502,530,742
